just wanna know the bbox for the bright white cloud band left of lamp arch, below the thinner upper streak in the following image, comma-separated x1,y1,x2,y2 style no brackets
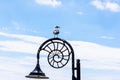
0,41,38,53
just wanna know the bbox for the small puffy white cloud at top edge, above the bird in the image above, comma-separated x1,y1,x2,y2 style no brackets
35,0,62,7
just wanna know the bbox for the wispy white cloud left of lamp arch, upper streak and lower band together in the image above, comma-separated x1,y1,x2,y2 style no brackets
0,32,46,53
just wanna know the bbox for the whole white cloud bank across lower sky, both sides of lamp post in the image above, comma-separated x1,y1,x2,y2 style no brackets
0,32,120,80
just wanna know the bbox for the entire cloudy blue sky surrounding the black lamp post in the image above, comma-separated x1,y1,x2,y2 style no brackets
0,0,120,80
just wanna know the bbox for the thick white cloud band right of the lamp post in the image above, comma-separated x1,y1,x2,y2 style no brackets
71,41,120,70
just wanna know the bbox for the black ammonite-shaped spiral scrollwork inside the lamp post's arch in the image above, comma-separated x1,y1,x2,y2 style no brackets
41,38,72,68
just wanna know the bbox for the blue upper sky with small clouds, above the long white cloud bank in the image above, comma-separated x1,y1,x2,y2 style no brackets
0,0,120,48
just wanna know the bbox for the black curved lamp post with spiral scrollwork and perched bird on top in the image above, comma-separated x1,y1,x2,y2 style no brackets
26,26,81,80
